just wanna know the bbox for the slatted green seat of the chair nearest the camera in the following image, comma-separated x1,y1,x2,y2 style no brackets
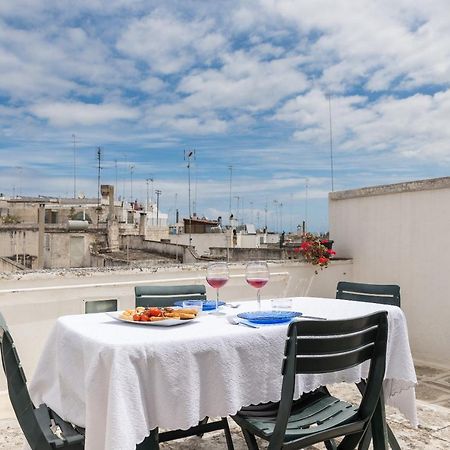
233,392,364,442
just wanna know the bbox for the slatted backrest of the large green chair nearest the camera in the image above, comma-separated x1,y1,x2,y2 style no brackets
277,311,388,432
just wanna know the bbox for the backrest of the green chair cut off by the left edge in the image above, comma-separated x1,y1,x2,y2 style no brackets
0,313,51,450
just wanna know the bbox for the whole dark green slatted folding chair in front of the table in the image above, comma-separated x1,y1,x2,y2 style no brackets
233,311,388,450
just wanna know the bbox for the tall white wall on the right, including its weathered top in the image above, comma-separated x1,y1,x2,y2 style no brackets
329,177,450,367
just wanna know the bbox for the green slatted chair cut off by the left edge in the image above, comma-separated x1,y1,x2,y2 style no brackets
0,313,84,450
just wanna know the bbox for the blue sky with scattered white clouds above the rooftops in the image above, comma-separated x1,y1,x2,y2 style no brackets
0,0,450,232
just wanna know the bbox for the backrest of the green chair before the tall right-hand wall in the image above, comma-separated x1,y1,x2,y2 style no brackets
336,281,400,307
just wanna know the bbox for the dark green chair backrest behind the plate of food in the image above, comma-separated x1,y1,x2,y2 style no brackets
134,284,206,306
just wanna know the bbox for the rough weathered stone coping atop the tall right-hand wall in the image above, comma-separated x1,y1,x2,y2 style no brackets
328,177,450,200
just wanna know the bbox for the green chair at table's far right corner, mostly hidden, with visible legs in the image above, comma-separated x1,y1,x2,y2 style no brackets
336,281,400,450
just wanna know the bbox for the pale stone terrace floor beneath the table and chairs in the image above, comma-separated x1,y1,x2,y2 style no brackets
0,365,450,450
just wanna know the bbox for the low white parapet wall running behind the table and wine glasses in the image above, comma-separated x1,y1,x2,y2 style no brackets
0,260,352,419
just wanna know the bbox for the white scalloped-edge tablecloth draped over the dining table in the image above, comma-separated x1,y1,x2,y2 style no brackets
30,298,417,450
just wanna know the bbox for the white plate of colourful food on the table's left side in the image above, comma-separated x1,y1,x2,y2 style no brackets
107,306,197,327
